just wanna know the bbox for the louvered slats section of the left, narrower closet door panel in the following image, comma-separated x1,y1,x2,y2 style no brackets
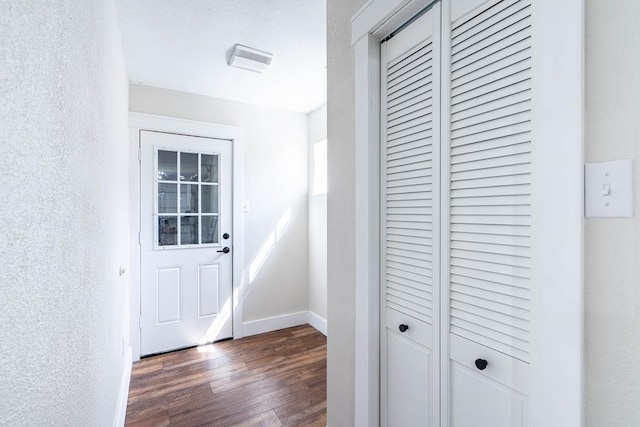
383,40,434,324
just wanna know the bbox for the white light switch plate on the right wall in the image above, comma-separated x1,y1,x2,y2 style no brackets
584,160,633,218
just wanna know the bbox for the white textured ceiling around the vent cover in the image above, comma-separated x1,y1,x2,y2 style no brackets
118,0,327,112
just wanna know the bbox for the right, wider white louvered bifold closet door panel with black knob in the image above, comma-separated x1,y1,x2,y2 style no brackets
445,0,532,427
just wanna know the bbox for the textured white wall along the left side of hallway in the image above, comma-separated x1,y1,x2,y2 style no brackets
0,0,129,426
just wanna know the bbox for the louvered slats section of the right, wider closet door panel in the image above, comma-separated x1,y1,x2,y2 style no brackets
449,0,532,362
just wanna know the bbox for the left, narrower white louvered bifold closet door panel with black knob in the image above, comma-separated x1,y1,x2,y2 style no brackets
381,5,440,427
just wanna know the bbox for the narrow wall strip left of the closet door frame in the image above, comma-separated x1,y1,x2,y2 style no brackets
327,0,364,427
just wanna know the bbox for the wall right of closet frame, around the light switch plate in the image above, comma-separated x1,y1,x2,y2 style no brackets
585,0,640,427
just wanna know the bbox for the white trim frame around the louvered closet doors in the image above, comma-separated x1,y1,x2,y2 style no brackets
351,0,584,427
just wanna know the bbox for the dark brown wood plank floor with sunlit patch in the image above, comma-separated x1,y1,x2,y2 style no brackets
126,325,327,427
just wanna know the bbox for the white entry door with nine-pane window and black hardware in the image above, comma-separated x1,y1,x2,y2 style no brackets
140,131,233,355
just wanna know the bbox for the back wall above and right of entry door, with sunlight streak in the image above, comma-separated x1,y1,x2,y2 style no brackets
129,85,308,322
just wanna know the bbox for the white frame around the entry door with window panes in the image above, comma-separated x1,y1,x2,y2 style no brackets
129,113,244,361
